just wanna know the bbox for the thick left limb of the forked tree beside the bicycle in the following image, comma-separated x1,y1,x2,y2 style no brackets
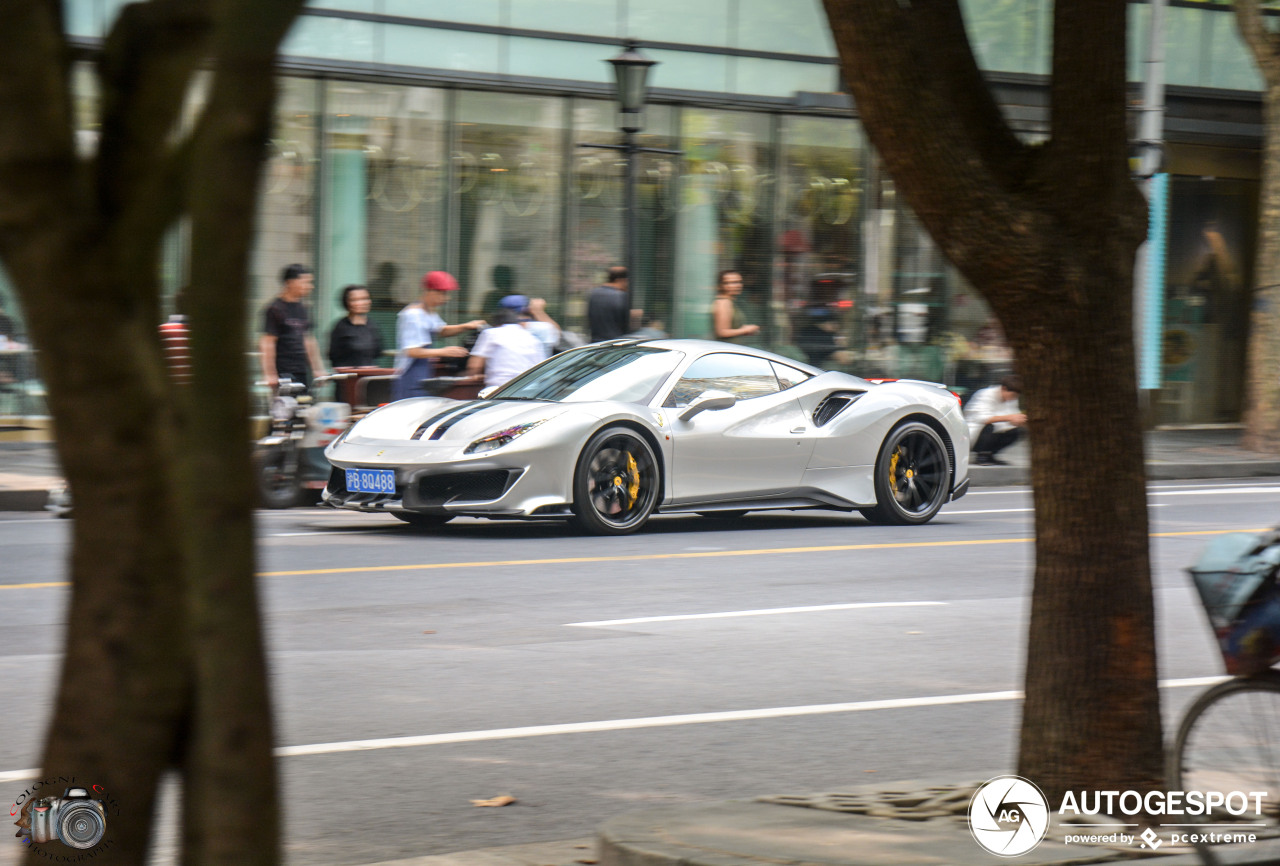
824,0,1043,294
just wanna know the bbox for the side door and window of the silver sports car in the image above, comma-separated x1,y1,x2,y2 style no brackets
663,352,813,504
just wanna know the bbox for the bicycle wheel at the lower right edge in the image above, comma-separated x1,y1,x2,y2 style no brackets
1165,670,1280,826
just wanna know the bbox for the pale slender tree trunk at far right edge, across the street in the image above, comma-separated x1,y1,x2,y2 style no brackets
1235,0,1280,453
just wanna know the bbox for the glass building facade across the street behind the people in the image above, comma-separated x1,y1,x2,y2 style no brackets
0,0,1261,422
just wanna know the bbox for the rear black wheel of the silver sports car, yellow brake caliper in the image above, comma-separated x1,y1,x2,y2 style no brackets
859,421,951,526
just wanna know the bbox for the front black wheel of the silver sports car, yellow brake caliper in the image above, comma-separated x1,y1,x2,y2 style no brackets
573,427,662,535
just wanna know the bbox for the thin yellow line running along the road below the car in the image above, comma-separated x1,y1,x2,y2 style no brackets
0,519,1267,590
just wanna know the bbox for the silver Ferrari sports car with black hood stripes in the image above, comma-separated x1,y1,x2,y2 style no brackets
324,339,969,535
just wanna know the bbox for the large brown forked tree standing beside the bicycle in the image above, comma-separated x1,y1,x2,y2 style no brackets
826,0,1162,799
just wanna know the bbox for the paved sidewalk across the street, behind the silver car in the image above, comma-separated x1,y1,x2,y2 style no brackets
0,427,1280,512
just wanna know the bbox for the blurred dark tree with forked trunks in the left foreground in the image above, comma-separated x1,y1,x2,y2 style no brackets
0,0,302,866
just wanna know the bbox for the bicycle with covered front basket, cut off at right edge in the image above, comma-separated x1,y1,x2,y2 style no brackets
1165,531,1280,831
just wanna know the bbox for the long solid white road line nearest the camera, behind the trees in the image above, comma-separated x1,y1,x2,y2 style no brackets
0,677,1230,783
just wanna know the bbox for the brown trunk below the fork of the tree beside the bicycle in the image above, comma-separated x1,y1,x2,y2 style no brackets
1015,275,1164,799
